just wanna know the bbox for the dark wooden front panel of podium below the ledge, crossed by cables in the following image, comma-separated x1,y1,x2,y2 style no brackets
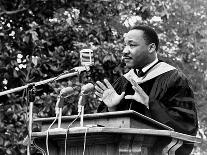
35,133,120,155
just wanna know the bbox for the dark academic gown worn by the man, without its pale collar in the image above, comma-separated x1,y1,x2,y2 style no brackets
98,69,198,155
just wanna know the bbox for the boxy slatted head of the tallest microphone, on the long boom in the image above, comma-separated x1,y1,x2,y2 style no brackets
80,49,94,66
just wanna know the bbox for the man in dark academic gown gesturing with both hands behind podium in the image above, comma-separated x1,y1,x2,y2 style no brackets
95,26,198,155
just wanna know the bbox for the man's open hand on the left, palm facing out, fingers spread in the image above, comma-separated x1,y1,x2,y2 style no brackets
95,79,125,108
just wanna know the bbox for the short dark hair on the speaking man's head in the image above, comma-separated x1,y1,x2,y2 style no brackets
131,25,159,51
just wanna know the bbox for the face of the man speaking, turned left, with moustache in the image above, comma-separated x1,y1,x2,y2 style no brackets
123,30,149,68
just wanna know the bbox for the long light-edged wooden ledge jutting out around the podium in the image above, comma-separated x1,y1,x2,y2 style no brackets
32,127,202,143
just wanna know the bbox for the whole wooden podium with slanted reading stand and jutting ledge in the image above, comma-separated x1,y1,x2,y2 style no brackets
32,110,201,155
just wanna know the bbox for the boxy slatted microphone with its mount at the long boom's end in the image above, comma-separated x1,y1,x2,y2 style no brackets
73,49,94,73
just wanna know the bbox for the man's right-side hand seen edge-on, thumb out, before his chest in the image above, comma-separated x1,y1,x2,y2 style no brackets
125,79,149,108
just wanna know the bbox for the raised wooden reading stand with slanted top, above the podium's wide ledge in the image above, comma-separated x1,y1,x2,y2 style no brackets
34,110,173,131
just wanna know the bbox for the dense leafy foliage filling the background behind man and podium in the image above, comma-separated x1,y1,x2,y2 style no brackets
0,0,207,155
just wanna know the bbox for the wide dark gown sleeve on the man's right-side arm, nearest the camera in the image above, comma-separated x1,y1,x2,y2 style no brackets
149,70,198,135
